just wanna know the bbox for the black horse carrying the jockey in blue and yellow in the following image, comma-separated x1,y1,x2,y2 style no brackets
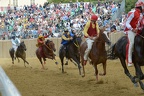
59,35,82,74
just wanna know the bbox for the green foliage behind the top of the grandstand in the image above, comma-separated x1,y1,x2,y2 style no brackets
47,0,137,13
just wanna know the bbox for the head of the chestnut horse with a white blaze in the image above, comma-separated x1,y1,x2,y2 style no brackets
99,27,111,45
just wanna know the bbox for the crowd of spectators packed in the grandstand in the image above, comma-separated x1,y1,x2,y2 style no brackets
0,1,125,40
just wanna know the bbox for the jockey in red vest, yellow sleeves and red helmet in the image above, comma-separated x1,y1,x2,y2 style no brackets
84,15,99,65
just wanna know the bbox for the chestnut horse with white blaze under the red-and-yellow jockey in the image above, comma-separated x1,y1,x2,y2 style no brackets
80,28,111,81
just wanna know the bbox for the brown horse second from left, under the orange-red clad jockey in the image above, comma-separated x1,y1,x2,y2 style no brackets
36,39,58,69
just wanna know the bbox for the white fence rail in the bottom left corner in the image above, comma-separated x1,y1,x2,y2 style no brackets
0,66,21,96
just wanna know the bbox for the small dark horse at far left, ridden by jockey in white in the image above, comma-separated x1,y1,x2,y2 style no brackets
9,41,29,67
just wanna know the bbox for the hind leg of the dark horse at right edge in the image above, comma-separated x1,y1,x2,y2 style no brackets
119,57,138,86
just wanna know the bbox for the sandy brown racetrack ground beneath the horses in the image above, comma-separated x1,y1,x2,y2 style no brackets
0,58,144,96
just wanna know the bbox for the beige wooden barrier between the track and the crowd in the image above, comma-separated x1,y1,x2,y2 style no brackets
0,32,124,58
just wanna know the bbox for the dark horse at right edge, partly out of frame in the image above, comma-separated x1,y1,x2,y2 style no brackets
112,28,144,90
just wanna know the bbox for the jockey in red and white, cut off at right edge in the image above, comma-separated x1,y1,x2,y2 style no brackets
124,0,144,66
